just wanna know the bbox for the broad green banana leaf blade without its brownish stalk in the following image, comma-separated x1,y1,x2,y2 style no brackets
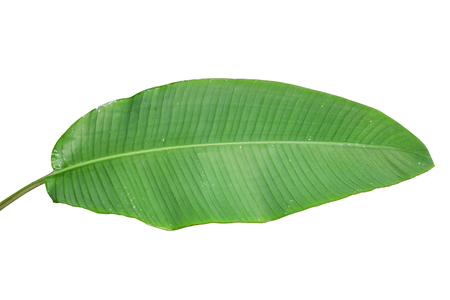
45,79,433,230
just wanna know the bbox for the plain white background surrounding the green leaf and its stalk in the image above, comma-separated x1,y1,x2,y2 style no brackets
0,0,450,300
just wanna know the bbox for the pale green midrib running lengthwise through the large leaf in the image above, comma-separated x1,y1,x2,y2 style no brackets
46,141,428,178
